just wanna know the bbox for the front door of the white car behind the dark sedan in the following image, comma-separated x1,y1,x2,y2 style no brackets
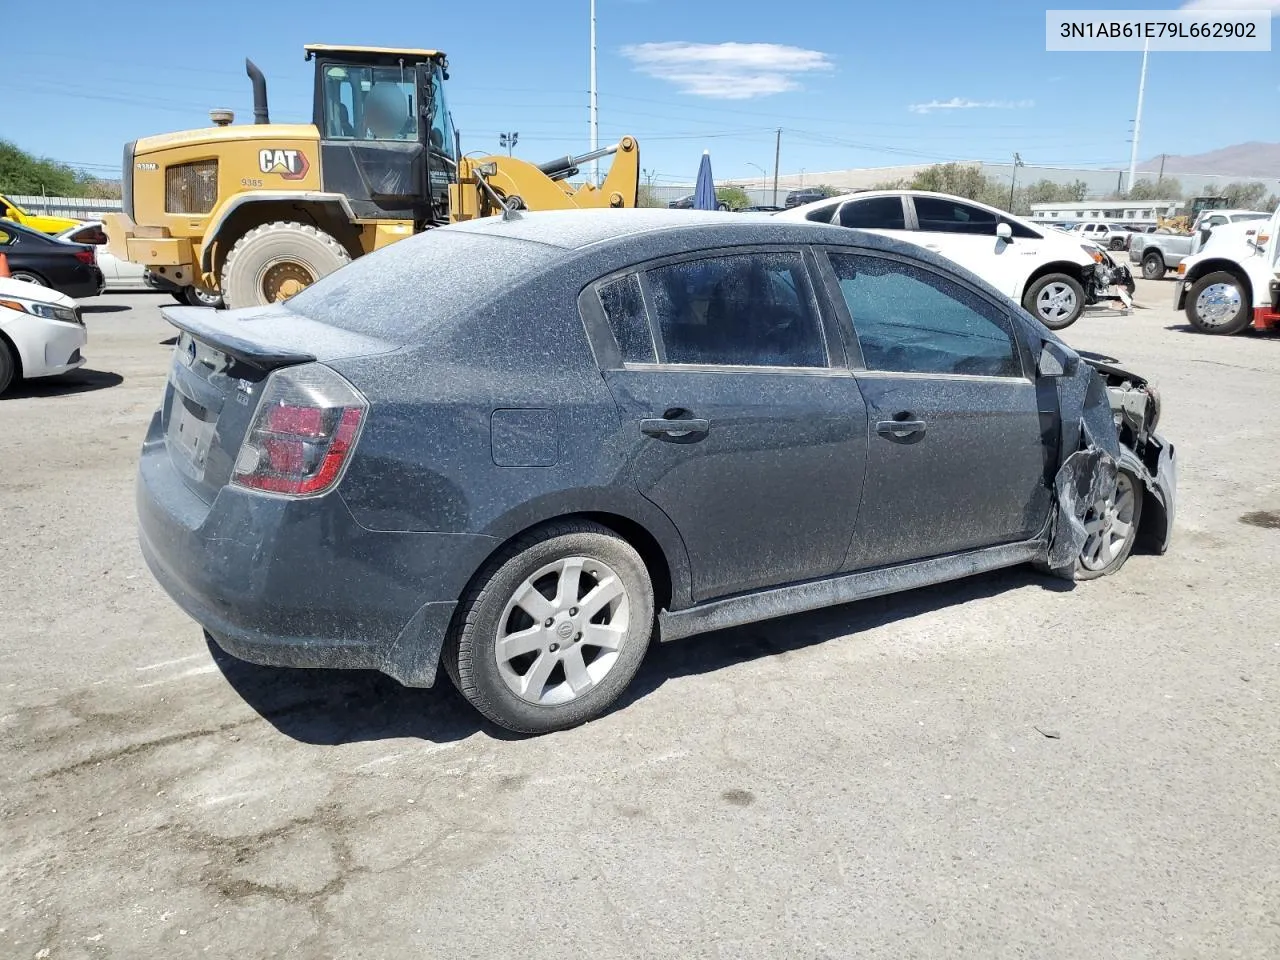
911,196,1039,297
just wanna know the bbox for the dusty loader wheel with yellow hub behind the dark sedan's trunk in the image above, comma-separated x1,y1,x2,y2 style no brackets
221,220,351,307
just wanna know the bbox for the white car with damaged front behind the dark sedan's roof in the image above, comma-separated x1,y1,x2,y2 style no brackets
774,189,1123,330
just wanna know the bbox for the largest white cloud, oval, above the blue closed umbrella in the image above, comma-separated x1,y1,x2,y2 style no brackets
622,40,835,100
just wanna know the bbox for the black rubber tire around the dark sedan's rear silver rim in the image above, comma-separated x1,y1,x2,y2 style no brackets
443,521,654,733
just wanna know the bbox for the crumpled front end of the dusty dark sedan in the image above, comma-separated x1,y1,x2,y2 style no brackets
1044,344,1178,580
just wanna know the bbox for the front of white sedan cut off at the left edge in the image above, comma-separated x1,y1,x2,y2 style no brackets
0,276,88,393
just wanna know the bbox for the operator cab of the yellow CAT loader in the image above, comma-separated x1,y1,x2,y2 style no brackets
306,44,457,228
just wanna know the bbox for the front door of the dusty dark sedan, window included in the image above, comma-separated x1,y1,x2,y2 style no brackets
828,250,1057,570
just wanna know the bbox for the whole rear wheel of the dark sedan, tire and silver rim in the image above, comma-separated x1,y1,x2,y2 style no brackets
444,521,654,733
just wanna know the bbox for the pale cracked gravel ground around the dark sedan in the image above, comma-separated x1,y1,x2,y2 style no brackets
0,280,1280,960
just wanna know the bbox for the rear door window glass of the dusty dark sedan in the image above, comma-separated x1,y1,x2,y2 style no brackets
648,251,827,367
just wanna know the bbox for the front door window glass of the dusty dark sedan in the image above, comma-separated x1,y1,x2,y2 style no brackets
831,253,1023,376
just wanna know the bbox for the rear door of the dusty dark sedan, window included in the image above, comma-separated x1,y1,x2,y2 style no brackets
596,248,867,600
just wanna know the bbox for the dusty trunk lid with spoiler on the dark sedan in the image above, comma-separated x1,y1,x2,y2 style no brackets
160,305,399,503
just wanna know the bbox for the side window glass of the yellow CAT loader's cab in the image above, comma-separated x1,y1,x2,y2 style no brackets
324,64,417,141
